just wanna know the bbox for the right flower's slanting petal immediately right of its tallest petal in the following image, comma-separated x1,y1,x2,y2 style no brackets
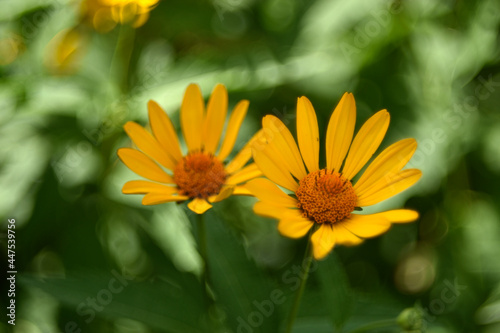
342,110,390,180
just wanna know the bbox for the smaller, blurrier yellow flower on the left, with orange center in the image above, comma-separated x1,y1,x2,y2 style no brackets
118,84,262,214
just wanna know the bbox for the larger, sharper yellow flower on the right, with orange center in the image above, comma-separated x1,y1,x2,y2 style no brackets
245,93,422,259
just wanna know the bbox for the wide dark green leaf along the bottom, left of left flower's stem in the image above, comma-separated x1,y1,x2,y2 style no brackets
18,270,205,333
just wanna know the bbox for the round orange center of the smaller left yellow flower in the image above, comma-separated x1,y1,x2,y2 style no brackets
174,152,226,199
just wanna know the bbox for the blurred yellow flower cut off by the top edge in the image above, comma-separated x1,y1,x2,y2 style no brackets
81,0,159,32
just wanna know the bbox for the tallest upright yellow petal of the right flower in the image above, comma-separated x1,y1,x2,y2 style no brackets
326,93,356,172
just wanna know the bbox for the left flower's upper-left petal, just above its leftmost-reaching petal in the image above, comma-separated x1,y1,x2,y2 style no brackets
123,121,175,170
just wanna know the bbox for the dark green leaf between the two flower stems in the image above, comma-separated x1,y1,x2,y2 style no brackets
205,210,283,333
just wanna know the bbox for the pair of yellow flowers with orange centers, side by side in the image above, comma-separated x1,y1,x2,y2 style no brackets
118,84,422,259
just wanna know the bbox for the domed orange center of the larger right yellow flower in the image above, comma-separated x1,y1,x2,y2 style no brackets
295,169,358,223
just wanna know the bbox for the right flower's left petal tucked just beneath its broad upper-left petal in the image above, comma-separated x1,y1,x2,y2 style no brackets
253,147,299,192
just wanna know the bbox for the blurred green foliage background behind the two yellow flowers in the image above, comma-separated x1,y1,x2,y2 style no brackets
0,0,500,333
